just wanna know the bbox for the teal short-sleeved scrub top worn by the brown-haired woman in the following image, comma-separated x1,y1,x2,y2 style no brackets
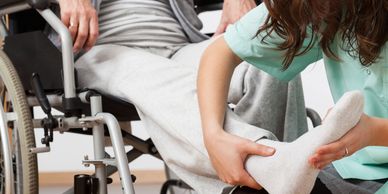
224,4,388,193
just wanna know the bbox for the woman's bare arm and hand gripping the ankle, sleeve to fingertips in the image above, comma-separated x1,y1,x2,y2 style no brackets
197,37,274,189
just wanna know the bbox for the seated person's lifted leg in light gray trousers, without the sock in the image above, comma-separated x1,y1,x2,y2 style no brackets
76,45,275,194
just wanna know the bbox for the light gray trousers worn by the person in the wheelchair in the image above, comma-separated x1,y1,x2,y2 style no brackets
76,40,307,194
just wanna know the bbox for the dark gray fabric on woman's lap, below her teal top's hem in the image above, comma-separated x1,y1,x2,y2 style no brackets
318,165,387,194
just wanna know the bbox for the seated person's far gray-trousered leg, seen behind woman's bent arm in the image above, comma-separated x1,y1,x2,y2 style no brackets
172,39,307,141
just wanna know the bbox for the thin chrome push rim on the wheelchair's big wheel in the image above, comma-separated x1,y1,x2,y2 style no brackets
0,103,15,194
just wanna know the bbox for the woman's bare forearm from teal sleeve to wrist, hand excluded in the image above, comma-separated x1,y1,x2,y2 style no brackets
197,37,241,136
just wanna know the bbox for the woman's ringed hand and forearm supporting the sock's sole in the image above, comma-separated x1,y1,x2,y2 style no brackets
309,114,388,168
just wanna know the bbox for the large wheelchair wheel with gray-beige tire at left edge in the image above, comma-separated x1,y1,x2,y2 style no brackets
0,49,38,194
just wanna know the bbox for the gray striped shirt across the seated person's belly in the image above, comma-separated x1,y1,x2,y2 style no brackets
96,0,189,50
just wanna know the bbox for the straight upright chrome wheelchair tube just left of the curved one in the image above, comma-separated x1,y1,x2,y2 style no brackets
90,96,108,194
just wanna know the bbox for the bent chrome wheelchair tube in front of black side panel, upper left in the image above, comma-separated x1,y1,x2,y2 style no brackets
37,9,76,98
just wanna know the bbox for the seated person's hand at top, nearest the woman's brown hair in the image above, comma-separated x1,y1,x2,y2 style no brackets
214,0,257,36
